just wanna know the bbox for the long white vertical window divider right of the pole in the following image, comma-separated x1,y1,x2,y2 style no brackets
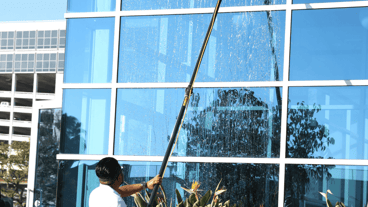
278,0,292,207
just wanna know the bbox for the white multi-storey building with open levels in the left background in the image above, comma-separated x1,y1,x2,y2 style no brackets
0,21,66,144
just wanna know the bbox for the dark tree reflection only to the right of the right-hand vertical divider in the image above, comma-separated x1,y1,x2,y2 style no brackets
285,102,335,206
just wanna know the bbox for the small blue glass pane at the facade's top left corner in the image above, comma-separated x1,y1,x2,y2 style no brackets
67,0,116,12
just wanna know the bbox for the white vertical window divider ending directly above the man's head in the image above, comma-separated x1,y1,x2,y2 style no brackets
108,4,121,156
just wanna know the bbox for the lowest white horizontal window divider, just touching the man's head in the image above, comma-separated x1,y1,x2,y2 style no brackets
56,154,368,166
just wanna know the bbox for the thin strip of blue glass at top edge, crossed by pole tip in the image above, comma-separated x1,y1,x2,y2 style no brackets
121,0,286,10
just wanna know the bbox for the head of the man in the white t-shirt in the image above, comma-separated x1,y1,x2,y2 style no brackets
96,157,124,185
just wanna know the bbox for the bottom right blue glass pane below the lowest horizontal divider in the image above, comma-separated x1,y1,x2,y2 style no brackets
284,165,368,207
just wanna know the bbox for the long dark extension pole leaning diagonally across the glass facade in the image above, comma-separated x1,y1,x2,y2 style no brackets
147,0,222,207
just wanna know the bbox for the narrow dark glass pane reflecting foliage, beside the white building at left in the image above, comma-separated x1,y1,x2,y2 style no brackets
32,109,61,206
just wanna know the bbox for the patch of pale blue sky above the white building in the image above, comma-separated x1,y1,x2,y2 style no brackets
0,0,67,22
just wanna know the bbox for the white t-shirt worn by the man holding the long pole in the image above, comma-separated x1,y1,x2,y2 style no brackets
89,184,126,207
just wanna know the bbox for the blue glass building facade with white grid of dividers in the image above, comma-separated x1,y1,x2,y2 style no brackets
57,0,368,207
